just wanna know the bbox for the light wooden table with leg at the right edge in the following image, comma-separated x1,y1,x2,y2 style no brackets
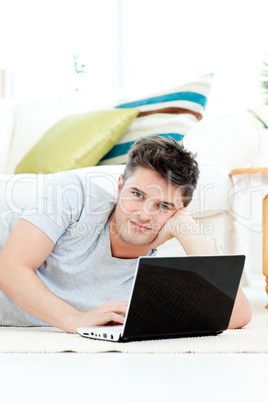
229,167,268,308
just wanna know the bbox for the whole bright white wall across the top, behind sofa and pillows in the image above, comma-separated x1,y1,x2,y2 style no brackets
0,0,268,114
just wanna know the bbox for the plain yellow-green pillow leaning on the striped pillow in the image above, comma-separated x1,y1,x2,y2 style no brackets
15,108,139,173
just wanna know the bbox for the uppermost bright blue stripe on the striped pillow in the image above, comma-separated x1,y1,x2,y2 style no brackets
116,92,207,109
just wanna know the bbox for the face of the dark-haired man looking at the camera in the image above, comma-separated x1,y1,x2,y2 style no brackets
111,168,183,246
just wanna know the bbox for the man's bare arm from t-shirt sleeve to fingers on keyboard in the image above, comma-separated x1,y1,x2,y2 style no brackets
0,219,127,333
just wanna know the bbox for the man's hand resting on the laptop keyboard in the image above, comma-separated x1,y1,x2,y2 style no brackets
70,301,128,333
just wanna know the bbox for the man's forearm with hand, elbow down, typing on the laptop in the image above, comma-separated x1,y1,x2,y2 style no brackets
0,264,128,333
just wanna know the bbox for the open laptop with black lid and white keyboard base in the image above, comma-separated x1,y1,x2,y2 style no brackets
77,255,245,342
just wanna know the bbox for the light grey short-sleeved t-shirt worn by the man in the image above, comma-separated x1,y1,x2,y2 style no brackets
0,173,156,326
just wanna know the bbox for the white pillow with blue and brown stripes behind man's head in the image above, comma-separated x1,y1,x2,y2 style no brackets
99,74,213,165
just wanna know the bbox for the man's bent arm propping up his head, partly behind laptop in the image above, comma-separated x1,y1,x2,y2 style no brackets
152,208,252,329
